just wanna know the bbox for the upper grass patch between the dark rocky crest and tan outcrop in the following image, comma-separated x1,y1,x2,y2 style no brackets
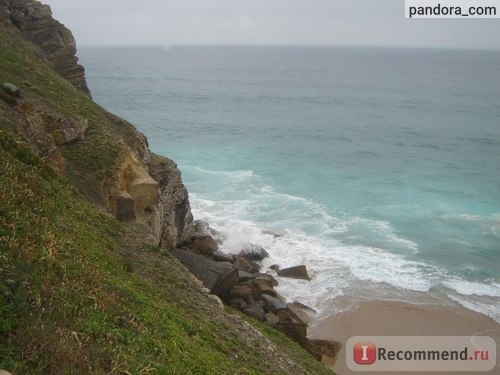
0,28,143,184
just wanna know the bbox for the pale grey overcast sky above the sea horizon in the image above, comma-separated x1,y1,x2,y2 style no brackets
42,0,500,49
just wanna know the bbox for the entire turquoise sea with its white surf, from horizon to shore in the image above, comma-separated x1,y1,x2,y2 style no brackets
79,47,500,321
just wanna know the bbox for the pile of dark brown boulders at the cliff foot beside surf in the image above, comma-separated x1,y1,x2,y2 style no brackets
172,221,340,359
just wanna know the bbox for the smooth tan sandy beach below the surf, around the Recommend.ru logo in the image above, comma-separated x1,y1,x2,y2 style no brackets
309,301,500,375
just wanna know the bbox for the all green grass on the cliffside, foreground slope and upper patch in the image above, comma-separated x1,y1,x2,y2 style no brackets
0,25,328,374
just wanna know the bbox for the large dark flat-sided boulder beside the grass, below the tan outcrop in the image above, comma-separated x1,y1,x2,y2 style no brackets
172,249,239,296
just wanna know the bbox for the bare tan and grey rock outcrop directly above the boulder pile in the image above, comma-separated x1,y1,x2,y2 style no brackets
107,138,193,248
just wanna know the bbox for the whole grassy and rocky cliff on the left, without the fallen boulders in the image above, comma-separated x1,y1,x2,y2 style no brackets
0,0,336,374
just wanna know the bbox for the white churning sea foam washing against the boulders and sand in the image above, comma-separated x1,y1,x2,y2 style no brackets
191,168,500,324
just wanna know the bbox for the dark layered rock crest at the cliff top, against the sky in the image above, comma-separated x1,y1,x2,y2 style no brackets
0,0,90,96
